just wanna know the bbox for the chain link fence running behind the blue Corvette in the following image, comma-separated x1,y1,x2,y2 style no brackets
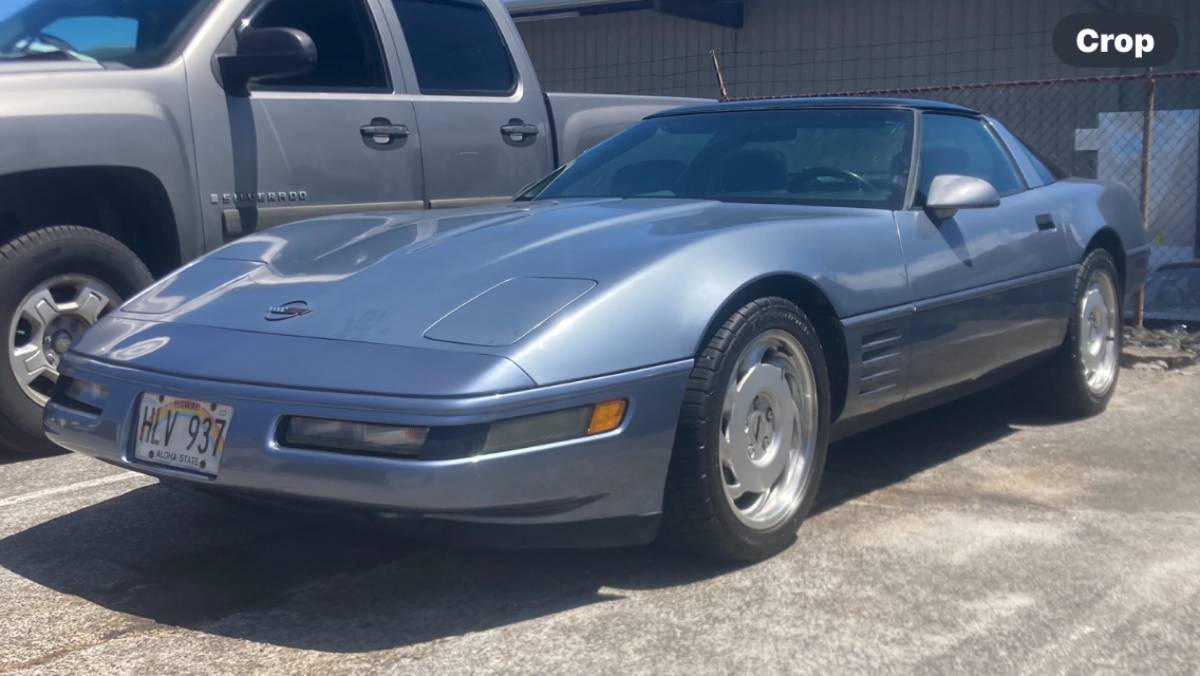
535,43,1200,317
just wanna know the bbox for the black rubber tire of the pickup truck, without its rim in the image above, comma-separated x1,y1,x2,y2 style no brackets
0,226,154,455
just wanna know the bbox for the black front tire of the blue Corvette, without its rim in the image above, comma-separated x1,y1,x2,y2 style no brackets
660,298,829,562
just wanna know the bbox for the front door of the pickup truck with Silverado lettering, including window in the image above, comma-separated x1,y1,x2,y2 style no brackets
188,0,425,247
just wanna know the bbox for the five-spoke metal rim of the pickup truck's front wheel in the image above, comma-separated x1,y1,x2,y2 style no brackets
8,274,121,406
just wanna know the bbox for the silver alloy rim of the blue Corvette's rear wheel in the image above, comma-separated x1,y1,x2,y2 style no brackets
1079,270,1121,395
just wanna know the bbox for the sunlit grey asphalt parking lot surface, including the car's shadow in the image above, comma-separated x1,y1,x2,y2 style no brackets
0,369,1200,674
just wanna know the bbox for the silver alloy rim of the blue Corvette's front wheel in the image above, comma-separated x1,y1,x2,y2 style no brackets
719,329,820,530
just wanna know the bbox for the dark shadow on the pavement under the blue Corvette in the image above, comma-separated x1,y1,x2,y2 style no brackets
0,384,1032,652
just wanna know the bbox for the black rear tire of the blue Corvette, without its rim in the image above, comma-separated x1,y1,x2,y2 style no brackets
1019,249,1123,418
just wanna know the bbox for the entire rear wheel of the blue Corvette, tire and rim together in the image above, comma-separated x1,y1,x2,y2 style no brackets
1021,250,1122,418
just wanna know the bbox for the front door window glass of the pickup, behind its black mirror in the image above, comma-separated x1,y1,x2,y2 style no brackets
251,0,389,90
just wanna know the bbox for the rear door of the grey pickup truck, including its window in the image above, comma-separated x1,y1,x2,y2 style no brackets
379,0,554,208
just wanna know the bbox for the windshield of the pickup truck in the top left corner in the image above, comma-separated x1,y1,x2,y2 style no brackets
0,0,214,68
